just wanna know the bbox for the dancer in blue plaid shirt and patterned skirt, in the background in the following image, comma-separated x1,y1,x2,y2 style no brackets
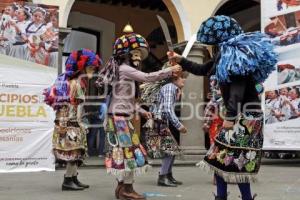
142,63,187,187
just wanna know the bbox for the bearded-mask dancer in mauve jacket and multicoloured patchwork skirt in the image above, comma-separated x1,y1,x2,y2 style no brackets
97,33,181,200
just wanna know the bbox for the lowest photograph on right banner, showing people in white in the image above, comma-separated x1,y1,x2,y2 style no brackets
265,85,300,124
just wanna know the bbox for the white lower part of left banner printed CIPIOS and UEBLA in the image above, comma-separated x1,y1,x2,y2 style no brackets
0,55,57,173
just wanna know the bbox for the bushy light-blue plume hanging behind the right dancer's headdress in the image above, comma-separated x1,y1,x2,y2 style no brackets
216,32,278,83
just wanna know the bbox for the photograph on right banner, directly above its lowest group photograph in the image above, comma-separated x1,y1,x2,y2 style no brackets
277,58,300,85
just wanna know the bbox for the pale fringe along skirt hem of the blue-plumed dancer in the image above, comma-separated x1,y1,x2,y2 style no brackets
196,160,257,183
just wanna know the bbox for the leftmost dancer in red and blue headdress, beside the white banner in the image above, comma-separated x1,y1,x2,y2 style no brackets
44,49,102,190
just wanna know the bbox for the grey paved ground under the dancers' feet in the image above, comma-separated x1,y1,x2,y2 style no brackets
0,161,300,200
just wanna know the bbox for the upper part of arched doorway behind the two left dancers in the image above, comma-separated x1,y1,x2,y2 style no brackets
64,0,191,156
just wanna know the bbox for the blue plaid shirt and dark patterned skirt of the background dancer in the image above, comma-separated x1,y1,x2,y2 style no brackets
141,63,181,159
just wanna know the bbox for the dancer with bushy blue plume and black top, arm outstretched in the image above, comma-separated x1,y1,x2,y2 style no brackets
168,16,277,200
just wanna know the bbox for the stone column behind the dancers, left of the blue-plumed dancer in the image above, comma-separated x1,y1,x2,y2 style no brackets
175,42,209,154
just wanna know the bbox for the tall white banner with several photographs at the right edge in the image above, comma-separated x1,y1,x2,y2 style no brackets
261,0,300,150
